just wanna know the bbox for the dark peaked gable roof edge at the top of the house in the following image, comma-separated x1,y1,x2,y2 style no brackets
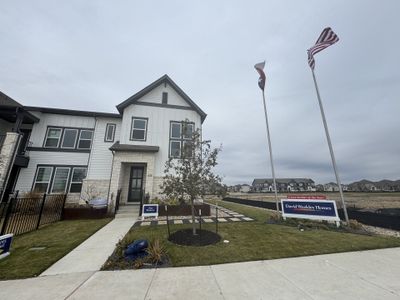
117,74,207,122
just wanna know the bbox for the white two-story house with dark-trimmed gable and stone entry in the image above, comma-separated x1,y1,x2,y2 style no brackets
0,75,206,209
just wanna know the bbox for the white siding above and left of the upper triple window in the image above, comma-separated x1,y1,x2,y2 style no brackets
30,112,95,147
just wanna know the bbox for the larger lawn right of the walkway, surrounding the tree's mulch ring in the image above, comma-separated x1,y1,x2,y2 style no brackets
104,201,400,269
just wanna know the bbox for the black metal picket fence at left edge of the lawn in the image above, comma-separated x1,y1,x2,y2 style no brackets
0,194,66,235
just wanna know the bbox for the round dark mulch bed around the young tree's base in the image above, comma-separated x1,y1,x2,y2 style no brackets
168,228,221,246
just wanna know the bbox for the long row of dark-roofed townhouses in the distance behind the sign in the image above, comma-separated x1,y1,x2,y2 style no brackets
251,178,316,193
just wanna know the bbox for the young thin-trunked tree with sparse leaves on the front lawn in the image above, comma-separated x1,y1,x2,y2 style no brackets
161,122,221,235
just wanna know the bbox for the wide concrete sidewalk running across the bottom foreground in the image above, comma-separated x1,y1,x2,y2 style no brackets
0,248,400,300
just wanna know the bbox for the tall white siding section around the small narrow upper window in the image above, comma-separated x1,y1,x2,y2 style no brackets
87,118,121,180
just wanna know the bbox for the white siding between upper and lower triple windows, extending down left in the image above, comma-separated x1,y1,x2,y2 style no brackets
15,151,89,192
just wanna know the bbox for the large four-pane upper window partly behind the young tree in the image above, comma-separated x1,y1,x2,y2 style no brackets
169,122,194,158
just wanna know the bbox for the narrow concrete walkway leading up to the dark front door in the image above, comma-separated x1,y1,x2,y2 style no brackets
40,206,139,276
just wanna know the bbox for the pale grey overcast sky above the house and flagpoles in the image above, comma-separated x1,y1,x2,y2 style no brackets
0,0,400,184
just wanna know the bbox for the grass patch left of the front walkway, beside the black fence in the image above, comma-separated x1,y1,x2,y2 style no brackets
0,219,110,280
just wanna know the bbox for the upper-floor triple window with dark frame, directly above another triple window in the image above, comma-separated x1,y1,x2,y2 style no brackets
44,127,93,150
